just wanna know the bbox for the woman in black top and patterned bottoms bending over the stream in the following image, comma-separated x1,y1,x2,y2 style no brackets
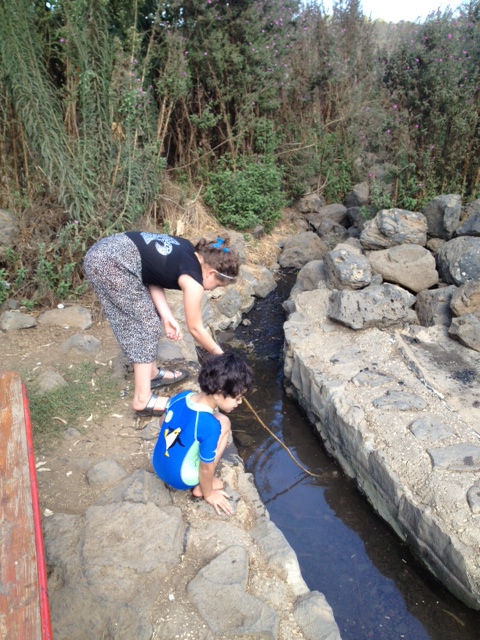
84,231,240,416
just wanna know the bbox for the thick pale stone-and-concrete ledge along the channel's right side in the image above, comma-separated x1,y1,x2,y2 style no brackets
284,290,480,609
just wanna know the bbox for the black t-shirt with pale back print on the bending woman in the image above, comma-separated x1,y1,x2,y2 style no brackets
125,231,203,289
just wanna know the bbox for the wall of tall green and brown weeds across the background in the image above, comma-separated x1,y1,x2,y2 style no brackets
0,0,480,299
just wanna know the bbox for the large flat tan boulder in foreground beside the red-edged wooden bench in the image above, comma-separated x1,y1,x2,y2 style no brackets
44,502,185,640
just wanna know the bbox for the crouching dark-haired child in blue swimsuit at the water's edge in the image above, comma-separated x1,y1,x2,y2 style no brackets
152,351,253,514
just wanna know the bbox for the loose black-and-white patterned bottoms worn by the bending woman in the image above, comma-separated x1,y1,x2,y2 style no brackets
83,233,162,363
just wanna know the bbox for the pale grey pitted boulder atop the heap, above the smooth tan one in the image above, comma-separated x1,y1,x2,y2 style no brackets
360,208,427,251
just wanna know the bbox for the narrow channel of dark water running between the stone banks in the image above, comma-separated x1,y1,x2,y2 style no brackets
222,274,480,640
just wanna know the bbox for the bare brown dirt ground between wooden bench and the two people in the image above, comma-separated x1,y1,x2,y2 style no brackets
0,312,181,515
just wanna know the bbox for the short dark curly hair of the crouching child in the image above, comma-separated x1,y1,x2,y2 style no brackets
198,351,253,398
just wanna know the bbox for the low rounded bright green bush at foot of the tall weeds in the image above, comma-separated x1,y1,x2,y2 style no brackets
205,158,285,231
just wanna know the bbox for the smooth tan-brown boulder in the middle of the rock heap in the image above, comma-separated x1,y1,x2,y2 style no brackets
368,244,438,293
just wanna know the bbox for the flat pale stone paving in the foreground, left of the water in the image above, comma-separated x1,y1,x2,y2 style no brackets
44,451,340,640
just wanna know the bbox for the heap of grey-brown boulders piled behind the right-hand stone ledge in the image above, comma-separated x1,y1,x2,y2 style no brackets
279,185,480,351
